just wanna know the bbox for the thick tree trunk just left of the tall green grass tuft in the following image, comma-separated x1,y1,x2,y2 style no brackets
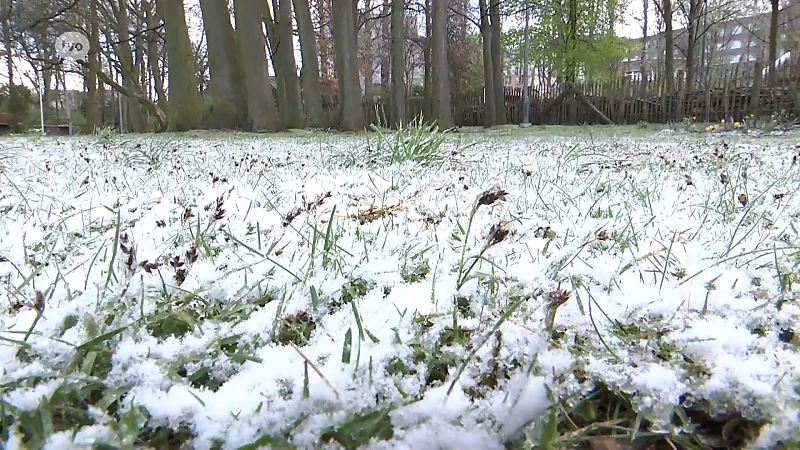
331,0,365,131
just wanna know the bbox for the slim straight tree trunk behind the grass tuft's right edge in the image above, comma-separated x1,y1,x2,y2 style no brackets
431,1,453,128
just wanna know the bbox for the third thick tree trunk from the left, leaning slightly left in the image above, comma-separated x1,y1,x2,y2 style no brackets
233,0,285,131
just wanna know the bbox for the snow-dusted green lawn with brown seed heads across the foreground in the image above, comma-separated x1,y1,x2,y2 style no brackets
0,128,800,449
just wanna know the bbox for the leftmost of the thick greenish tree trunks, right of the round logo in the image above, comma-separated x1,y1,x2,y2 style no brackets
156,0,203,131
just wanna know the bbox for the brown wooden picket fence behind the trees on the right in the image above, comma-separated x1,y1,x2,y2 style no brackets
326,64,800,126
